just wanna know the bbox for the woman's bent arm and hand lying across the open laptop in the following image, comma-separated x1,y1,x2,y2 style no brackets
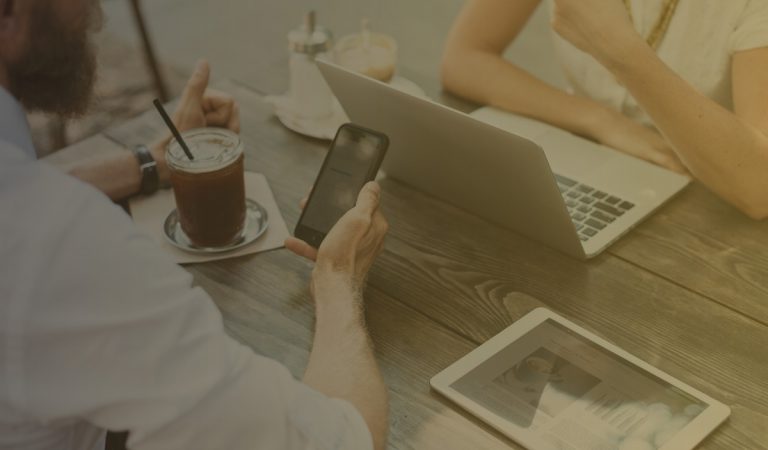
442,0,685,172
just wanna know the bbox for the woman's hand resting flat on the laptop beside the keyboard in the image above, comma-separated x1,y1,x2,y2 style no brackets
590,110,688,175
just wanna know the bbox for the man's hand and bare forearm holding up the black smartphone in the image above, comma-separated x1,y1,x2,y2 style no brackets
292,182,389,450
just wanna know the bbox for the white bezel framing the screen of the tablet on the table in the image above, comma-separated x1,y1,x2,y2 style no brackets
430,308,731,450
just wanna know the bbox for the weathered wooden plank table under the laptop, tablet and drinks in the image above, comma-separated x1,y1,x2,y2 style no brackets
48,76,768,450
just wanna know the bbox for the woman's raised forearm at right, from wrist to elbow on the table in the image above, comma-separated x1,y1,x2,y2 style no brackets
598,40,768,219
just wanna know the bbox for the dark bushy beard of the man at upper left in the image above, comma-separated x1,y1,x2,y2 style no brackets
7,2,101,117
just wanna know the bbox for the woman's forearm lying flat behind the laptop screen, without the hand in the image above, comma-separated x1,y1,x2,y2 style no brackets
442,49,615,140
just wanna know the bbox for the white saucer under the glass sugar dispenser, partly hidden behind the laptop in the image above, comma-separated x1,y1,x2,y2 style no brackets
264,76,427,141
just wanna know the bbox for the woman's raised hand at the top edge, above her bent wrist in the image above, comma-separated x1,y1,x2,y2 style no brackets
552,0,642,63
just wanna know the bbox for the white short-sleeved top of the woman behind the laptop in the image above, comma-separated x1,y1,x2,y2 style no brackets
548,0,768,126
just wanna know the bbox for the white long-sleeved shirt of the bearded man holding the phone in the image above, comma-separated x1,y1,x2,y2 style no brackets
0,85,373,450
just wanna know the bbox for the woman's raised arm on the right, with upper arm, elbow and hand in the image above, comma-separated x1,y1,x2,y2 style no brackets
554,0,768,219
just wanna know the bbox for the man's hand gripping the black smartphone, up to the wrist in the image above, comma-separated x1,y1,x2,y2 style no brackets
285,182,389,293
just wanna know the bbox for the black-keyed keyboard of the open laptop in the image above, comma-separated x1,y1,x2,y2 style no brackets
555,174,635,241
